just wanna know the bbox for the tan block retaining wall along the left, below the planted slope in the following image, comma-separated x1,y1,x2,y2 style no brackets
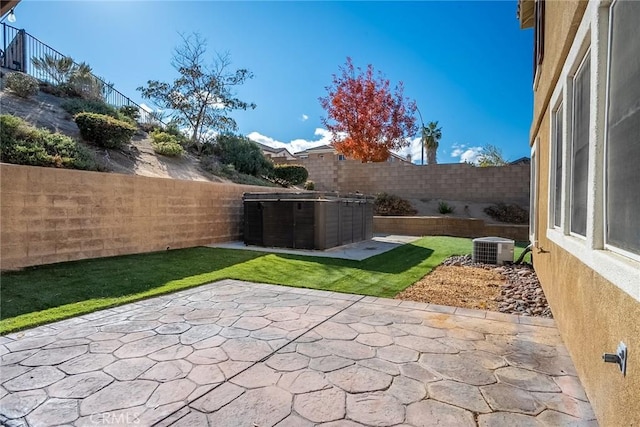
0,164,283,270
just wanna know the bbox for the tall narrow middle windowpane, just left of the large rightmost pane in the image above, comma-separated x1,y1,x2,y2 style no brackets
570,54,591,236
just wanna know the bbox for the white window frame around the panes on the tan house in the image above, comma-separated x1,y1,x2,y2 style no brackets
546,0,640,302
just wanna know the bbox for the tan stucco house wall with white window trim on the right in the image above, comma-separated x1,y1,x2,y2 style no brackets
521,0,640,426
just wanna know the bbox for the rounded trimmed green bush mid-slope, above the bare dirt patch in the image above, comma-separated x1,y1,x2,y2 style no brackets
75,113,136,148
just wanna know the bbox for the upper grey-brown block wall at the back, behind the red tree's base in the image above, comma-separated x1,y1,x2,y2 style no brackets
298,156,530,206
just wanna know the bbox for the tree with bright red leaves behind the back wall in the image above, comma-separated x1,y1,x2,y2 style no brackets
320,57,417,162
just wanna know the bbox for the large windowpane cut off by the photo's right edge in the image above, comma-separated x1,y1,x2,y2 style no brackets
605,0,640,255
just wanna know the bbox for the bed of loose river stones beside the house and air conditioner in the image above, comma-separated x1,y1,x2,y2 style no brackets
442,255,553,318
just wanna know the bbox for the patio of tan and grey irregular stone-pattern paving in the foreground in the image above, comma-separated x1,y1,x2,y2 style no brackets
0,280,597,427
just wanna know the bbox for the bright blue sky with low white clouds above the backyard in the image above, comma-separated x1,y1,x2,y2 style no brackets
13,0,533,163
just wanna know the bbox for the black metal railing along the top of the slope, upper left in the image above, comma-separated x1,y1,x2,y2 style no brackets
0,22,165,125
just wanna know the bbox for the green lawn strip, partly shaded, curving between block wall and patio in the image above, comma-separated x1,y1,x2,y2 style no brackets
0,236,524,334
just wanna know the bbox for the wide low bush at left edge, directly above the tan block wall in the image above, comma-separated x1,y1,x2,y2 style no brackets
0,114,98,170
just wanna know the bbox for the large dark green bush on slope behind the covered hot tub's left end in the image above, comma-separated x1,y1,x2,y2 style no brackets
214,134,276,179
